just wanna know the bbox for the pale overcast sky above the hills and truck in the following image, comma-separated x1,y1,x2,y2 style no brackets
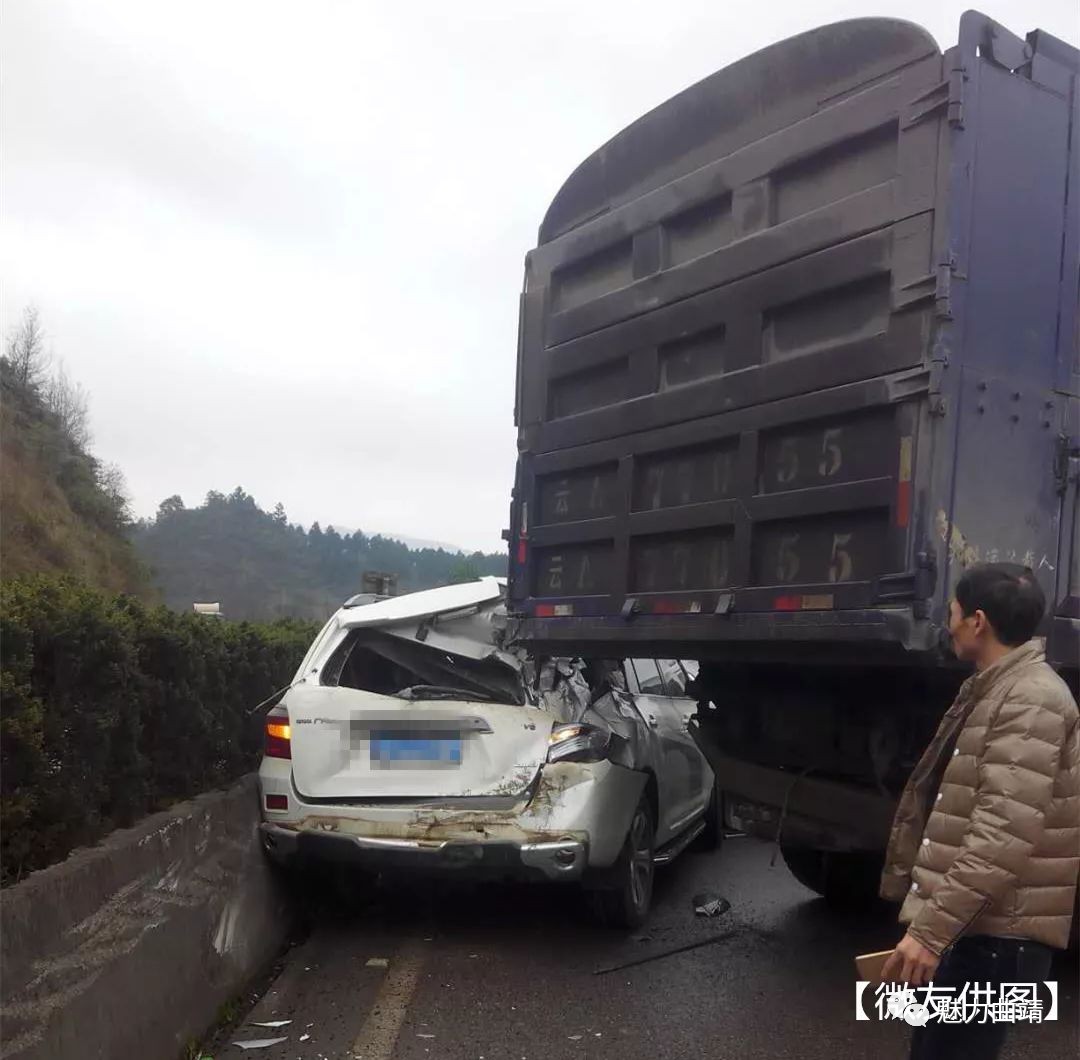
0,0,1080,549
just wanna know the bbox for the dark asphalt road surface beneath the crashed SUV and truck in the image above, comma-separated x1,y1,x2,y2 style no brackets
204,837,1080,1060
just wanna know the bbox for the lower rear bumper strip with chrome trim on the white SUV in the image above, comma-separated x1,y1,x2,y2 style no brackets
259,823,589,881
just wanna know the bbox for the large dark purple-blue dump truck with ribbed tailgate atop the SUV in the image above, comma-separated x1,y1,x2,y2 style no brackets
504,12,1080,902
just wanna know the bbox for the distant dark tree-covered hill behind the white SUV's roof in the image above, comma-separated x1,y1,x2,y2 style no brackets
134,486,507,620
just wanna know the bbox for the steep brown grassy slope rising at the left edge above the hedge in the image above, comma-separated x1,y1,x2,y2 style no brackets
0,358,151,596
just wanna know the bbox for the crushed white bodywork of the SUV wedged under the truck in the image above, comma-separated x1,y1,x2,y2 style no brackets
252,579,715,880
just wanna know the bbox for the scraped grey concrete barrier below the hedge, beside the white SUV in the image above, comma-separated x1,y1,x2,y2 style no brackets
0,776,291,1060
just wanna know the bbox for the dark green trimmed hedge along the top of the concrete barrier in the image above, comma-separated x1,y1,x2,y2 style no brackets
0,576,318,885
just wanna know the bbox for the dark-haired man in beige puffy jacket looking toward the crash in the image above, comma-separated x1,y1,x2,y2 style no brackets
880,564,1080,1060
